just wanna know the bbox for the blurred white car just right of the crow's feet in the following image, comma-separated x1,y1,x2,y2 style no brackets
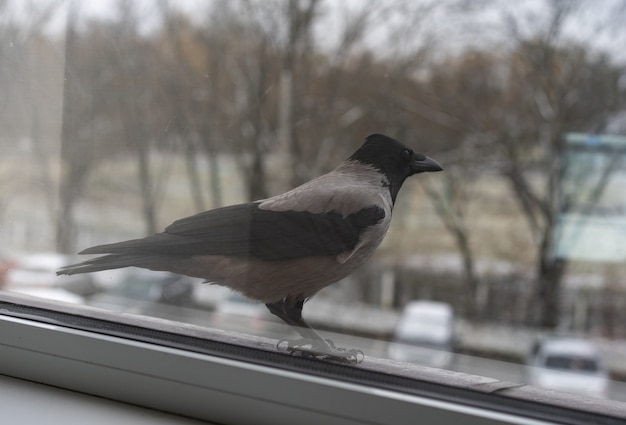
388,301,454,368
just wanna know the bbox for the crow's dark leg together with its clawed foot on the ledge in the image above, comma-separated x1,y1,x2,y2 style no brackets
265,297,364,363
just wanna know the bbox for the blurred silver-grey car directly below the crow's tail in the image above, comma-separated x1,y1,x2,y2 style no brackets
87,268,195,314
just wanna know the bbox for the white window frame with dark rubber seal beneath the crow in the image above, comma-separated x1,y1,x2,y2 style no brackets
0,293,626,425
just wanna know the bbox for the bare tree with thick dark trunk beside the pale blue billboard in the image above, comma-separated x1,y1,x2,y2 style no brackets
496,1,623,327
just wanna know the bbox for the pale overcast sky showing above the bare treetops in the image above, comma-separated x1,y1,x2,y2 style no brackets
7,0,626,63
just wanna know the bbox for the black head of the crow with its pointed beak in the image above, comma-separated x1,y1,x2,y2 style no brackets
348,134,443,202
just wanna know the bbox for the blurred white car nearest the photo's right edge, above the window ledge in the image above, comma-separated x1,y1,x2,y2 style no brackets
526,337,609,398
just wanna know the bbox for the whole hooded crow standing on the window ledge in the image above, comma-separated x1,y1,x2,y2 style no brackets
58,134,442,362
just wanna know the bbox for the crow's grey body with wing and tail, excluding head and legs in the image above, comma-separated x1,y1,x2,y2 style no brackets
58,162,392,303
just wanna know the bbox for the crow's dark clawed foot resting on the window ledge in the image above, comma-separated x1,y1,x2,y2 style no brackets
276,338,365,364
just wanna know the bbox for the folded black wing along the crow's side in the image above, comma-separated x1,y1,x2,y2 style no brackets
82,202,385,261
